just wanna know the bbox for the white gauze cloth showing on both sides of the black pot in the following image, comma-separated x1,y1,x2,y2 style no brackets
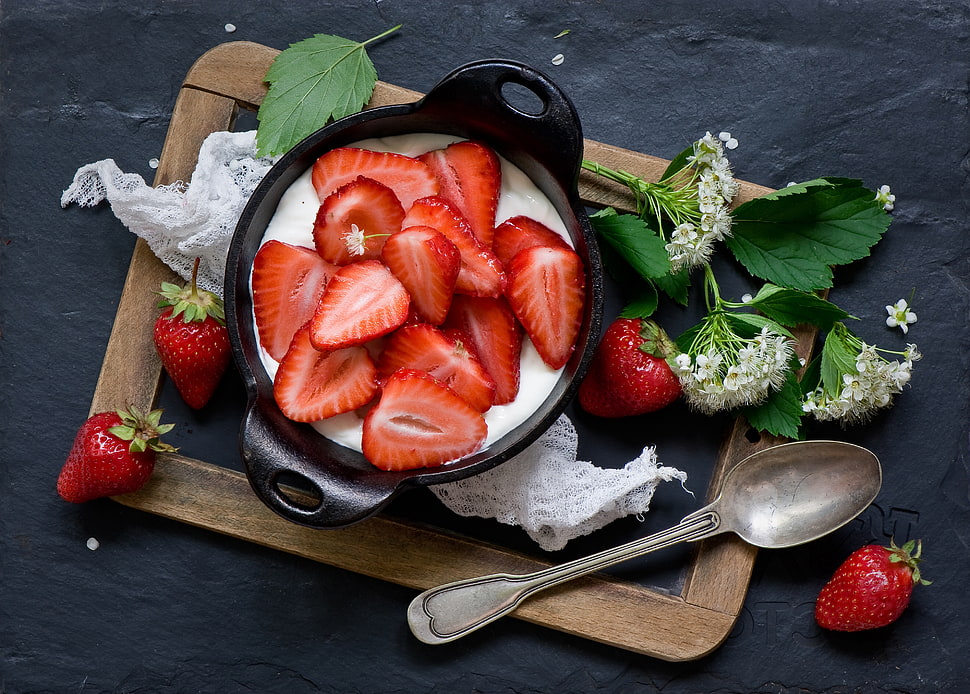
61,131,687,551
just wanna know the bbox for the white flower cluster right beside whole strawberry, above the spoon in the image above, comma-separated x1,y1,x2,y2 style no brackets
674,327,793,414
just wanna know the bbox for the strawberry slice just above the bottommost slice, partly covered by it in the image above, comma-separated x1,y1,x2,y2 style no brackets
377,323,495,412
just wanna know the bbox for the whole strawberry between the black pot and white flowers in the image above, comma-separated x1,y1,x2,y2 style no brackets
579,318,681,417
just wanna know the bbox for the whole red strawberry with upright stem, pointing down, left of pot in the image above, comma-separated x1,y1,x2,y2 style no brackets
154,258,232,410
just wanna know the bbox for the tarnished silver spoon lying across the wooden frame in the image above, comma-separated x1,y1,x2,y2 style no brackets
408,441,882,644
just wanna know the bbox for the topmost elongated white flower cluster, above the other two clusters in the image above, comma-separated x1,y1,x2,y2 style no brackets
666,132,739,272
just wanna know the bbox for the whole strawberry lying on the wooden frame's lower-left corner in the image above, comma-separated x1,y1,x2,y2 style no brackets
57,407,175,503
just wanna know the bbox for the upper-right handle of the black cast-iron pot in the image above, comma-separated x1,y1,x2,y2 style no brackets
421,60,583,186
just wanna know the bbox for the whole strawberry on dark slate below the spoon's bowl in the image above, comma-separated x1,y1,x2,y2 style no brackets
815,540,929,631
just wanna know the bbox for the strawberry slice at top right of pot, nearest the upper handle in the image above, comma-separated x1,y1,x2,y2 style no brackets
418,140,502,248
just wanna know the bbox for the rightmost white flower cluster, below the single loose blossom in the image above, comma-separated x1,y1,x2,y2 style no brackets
802,342,922,424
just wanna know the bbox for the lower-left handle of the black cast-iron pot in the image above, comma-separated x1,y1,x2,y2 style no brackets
240,400,399,528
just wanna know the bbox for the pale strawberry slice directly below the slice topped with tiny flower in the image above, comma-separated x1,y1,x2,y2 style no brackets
310,260,411,351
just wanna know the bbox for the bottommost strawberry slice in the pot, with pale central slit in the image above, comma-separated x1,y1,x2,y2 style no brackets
361,369,488,470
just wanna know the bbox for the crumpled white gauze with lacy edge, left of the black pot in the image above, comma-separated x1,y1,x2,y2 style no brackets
61,130,274,296
